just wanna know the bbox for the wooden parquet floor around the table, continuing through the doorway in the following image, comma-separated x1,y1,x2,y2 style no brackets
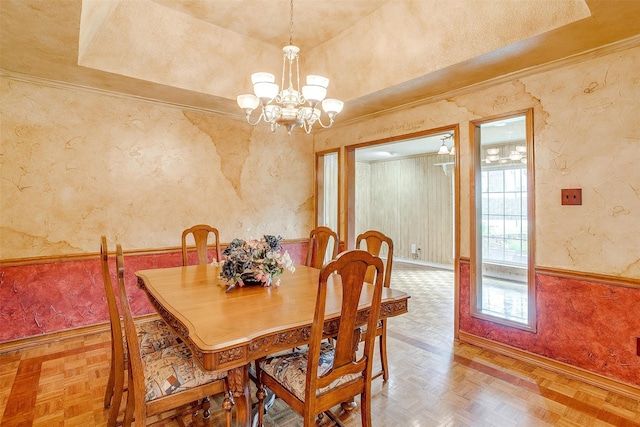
0,263,640,427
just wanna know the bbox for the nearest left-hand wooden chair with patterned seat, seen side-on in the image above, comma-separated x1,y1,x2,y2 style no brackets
116,244,233,427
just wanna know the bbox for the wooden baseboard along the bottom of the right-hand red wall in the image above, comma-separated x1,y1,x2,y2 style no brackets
458,331,640,400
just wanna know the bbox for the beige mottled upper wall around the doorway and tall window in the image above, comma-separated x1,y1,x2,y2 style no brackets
315,47,640,279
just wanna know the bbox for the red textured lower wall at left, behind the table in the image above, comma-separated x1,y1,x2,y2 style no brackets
0,242,307,342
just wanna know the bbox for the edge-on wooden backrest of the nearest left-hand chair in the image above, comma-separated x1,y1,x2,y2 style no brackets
116,244,147,425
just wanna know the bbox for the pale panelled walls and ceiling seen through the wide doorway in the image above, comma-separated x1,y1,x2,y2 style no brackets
346,127,457,270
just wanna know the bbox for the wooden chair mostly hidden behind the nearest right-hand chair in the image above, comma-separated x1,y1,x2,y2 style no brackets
356,230,393,381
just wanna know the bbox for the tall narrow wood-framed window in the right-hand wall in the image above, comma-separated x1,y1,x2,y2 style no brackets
471,112,535,330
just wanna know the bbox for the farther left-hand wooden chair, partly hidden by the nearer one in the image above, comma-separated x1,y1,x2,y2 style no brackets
100,236,180,427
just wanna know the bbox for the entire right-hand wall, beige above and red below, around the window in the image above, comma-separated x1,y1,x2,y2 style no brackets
315,47,640,387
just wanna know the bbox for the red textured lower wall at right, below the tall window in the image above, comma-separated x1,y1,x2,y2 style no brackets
460,264,640,386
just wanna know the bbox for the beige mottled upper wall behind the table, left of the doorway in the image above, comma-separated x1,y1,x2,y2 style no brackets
0,77,313,260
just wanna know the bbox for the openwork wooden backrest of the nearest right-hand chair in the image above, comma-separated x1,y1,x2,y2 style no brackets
305,249,383,413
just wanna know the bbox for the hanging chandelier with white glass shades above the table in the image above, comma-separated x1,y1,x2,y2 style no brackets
237,0,344,135
